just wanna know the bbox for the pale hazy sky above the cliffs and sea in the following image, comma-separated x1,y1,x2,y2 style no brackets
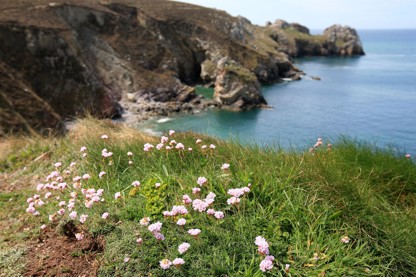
173,0,416,30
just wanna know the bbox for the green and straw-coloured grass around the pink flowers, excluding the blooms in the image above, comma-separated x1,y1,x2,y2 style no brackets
0,119,416,276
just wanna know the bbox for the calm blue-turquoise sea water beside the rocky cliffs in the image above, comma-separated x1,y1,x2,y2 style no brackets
141,30,416,153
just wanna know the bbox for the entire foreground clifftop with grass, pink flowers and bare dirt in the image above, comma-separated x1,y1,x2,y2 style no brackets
0,117,416,276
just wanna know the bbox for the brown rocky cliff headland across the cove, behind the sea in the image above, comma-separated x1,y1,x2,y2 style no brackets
0,0,363,135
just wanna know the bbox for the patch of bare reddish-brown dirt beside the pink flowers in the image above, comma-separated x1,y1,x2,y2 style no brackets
24,224,104,277
